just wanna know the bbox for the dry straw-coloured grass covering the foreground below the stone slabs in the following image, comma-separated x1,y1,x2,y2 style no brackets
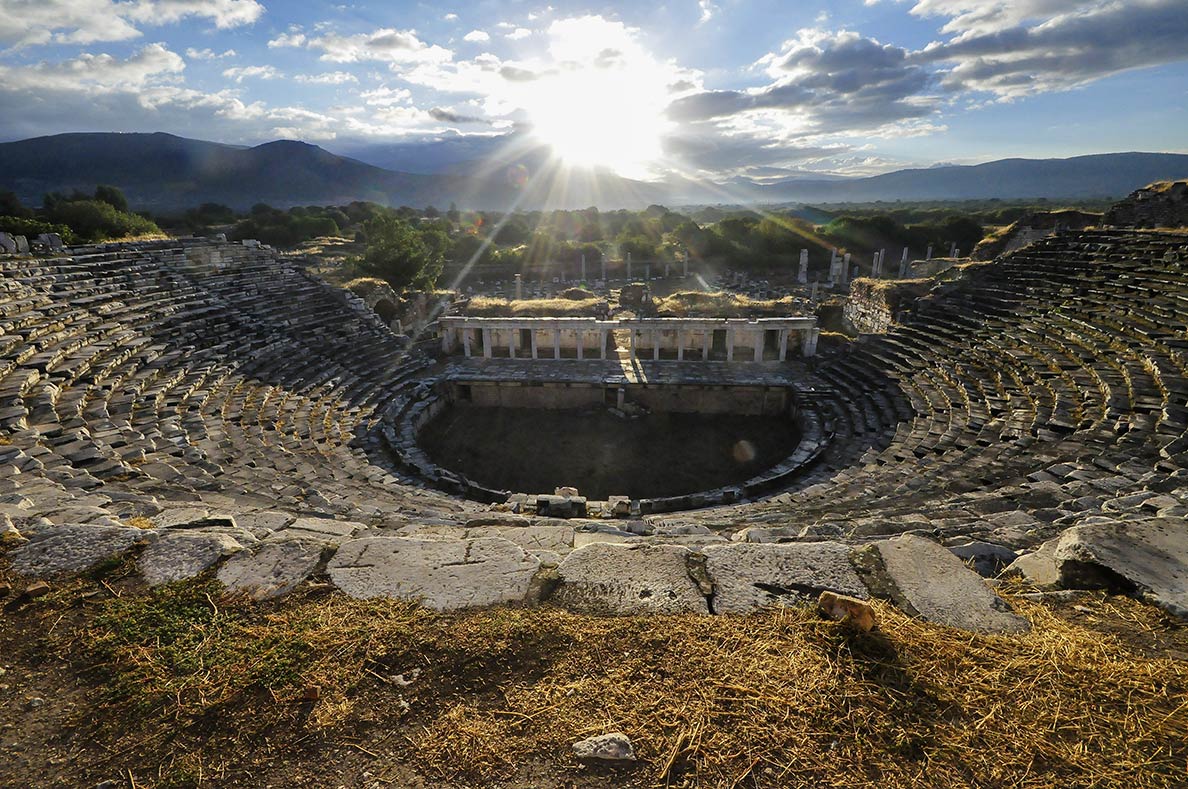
0,563,1188,788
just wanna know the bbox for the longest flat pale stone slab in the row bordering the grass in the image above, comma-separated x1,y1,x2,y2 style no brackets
327,537,541,611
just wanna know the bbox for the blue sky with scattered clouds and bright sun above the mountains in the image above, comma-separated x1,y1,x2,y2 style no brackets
0,0,1188,181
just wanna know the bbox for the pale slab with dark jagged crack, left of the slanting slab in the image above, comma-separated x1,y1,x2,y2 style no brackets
702,542,868,613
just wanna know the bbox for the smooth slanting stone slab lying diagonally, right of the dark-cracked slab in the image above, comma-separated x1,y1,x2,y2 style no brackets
853,535,1031,633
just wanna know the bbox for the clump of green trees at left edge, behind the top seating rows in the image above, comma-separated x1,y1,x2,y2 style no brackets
0,185,160,244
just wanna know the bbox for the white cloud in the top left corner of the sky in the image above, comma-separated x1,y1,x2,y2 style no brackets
0,0,264,48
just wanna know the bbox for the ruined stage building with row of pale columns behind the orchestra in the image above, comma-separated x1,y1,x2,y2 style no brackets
438,316,821,361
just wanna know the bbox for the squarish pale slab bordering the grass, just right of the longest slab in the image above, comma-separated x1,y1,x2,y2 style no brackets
552,543,709,614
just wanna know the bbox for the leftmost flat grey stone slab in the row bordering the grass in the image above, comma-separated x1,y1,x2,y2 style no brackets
8,524,156,577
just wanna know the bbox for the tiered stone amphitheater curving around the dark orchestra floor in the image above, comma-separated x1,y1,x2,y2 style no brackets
0,219,1188,631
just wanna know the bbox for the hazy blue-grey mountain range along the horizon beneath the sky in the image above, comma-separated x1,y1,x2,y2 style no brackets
0,133,1188,212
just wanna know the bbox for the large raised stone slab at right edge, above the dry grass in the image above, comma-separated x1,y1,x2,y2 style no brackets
1053,518,1188,617
